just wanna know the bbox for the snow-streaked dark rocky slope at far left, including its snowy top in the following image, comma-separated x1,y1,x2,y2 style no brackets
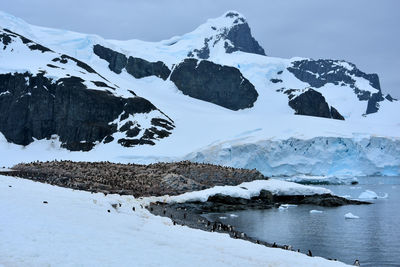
0,29,174,151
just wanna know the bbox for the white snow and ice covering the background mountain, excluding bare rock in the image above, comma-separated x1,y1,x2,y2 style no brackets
0,12,400,176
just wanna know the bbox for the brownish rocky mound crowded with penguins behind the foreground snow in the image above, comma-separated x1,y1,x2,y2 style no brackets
2,161,267,197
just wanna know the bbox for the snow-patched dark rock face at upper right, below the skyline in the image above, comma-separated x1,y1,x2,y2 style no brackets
287,59,384,114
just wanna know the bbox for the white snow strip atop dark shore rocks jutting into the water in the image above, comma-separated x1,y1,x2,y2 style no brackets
147,179,332,203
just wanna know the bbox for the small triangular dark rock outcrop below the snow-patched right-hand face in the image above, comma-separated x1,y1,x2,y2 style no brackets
289,89,344,120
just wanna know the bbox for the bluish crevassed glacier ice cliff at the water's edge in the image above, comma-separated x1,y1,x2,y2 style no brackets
185,137,400,177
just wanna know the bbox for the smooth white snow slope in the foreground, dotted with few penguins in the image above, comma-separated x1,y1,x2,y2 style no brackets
0,176,346,266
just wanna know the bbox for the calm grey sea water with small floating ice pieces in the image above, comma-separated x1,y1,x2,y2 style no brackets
206,177,400,267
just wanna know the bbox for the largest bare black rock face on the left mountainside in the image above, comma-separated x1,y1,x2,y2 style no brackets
0,73,174,151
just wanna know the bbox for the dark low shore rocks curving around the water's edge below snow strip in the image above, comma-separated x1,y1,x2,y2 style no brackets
146,184,371,256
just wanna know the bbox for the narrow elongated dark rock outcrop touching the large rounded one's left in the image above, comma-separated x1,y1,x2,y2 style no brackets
93,44,171,80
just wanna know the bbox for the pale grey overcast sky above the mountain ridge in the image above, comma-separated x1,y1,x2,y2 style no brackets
0,0,400,98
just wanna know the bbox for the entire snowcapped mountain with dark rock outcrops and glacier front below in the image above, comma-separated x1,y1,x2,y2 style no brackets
0,11,400,178
